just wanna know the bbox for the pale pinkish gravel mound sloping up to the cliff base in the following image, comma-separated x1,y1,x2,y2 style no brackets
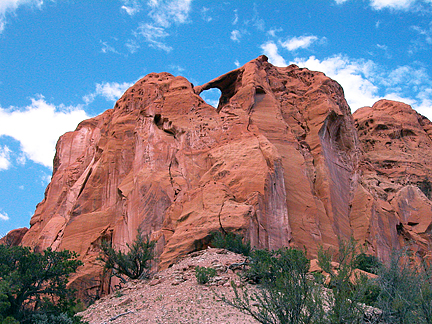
79,248,258,324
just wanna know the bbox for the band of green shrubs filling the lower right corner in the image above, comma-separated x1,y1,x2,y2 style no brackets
222,239,432,324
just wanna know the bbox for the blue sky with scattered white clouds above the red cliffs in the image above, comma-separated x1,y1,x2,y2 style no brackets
0,0,432,236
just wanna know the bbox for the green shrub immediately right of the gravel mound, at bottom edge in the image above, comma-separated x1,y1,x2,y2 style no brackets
223,248,323,324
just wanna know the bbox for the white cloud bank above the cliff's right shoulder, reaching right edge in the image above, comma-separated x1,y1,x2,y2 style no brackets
293,55,432,120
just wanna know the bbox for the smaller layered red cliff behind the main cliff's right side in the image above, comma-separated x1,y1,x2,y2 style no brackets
351,100,432,257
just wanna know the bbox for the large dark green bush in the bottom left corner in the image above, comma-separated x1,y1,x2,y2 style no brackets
0,245,82,323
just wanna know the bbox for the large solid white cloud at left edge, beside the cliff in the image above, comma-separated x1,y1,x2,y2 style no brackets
0,96,89,167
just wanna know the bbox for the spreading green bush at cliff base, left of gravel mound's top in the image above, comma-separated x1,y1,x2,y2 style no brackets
100,231,155,279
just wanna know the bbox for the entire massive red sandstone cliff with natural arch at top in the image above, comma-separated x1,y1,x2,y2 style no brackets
8,56,432,295
